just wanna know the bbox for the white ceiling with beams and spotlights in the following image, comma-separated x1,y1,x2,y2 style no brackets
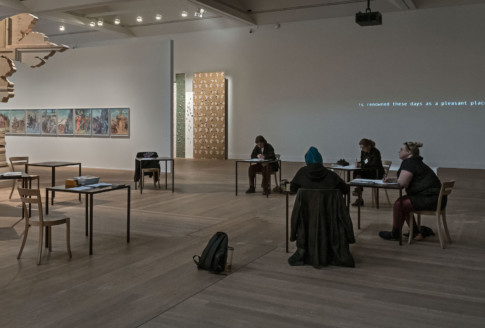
0,0,485,46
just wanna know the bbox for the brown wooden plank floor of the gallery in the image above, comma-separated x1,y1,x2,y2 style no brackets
0,160,485,328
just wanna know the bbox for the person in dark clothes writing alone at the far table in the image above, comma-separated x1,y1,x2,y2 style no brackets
246,136,278,195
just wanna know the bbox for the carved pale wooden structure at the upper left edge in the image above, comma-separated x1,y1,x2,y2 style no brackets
0,13,68,102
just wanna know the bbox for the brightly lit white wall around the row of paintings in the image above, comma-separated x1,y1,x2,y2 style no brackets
0,39,172,170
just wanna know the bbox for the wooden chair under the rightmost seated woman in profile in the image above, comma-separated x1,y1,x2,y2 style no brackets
408,181,455,248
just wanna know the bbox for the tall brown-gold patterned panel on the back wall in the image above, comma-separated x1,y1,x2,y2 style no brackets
193,72,227,159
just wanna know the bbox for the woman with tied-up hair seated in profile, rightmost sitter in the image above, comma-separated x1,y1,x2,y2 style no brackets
379,142,446,240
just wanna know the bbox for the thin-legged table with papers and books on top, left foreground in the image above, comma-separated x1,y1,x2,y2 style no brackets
45,184,131,255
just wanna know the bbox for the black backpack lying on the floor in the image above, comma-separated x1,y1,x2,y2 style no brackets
192,232,229,273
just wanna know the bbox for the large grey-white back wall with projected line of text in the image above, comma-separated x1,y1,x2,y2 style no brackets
171,5,485,168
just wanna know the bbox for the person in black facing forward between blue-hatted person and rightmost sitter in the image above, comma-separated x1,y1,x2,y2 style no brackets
352,138,384,206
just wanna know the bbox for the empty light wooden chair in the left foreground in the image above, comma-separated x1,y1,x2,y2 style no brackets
17,188,72,264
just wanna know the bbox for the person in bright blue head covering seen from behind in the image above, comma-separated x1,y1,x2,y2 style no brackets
290,146,349,194
